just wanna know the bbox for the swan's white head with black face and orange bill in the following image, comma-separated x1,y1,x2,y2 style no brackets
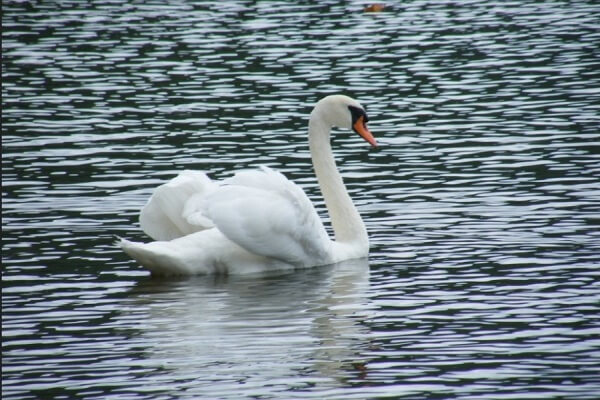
312,94,377,147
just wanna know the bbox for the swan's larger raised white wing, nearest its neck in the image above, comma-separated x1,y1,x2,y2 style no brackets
204,167,331,265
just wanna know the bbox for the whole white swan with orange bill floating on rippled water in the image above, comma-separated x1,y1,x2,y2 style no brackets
119,95,377,275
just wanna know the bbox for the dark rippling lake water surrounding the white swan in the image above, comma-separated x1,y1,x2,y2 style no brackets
2,0,600,400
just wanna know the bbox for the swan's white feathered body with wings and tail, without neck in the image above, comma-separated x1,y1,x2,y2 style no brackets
120,167,332,275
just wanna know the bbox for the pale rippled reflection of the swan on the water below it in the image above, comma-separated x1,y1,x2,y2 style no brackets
123,260,376,391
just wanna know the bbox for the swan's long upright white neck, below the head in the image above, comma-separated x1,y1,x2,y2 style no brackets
308,114,369,250
